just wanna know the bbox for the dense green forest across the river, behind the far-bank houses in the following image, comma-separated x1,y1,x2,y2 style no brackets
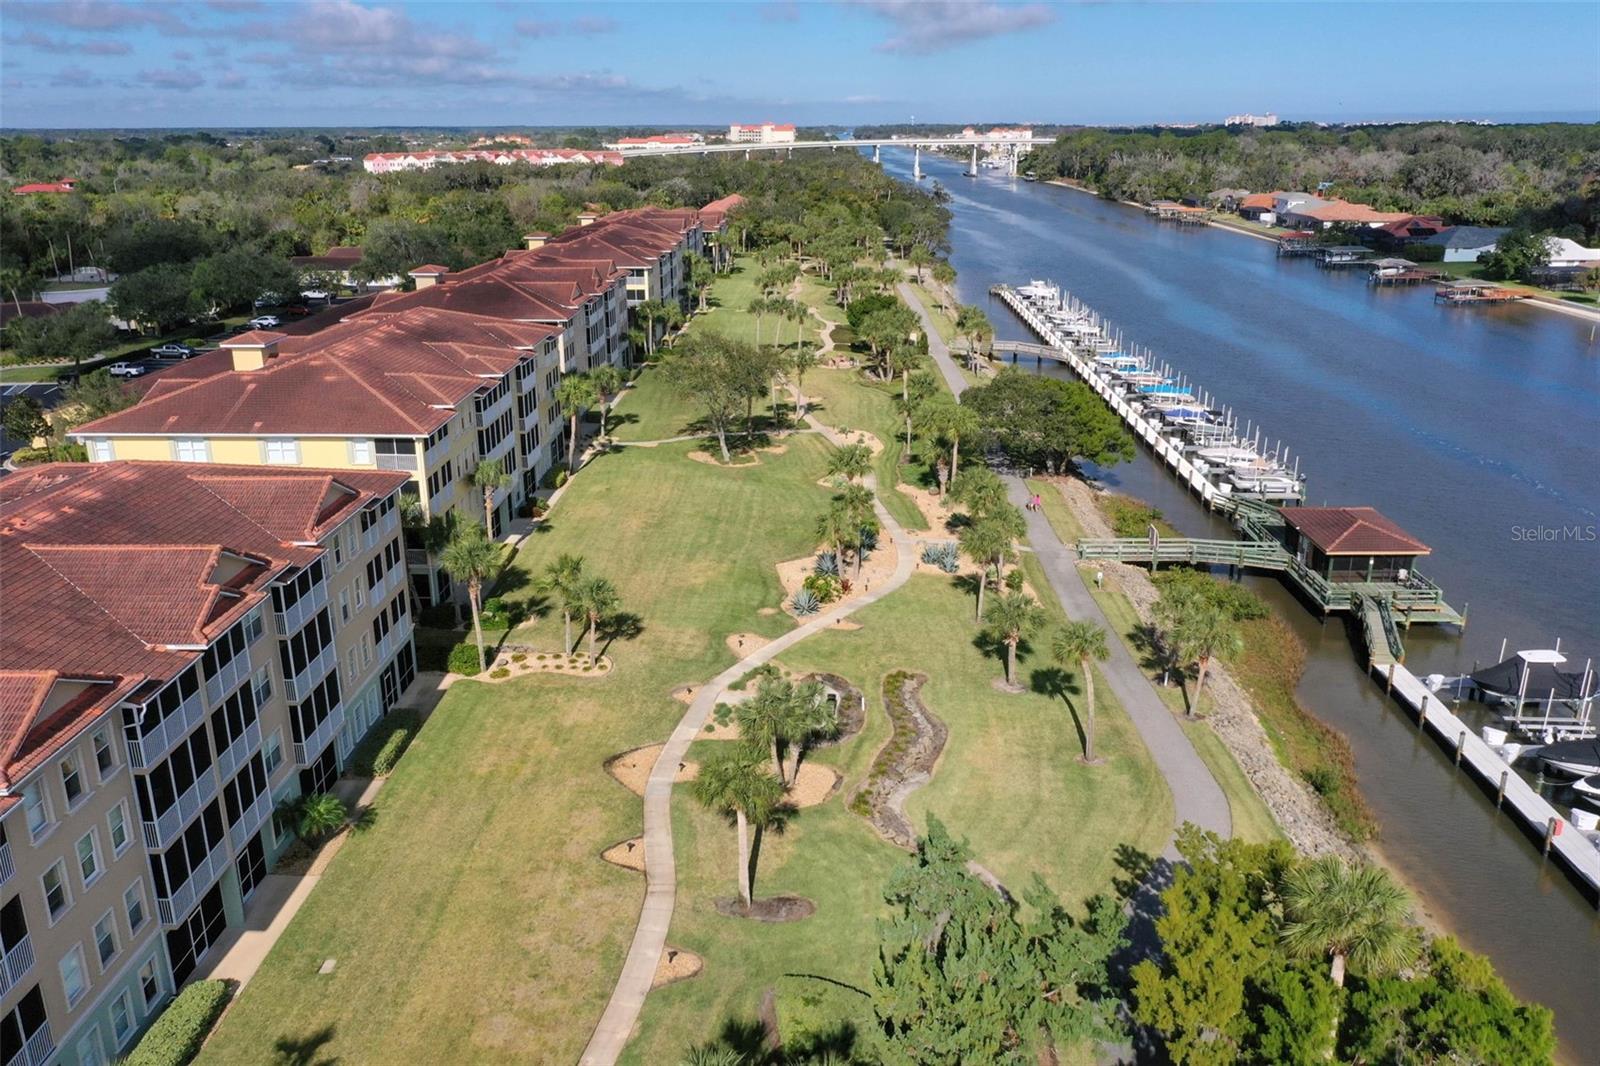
1024,122,1600,240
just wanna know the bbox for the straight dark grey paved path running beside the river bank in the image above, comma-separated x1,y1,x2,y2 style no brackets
899,283,1234,860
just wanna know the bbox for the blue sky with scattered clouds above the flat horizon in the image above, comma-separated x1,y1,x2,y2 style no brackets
0,0,1600,128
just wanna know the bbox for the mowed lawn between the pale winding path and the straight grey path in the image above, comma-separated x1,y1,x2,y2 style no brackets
624,575,1173,1063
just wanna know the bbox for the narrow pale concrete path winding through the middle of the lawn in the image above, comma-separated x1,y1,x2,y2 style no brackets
578,415,917,1066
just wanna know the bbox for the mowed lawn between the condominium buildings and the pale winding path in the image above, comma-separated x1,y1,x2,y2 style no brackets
202,437,827,1066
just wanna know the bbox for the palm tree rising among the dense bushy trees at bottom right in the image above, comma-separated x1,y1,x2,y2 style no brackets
1283,855,1421,988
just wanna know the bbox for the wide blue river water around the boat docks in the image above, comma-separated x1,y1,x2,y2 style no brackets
883,152,1600,1063
